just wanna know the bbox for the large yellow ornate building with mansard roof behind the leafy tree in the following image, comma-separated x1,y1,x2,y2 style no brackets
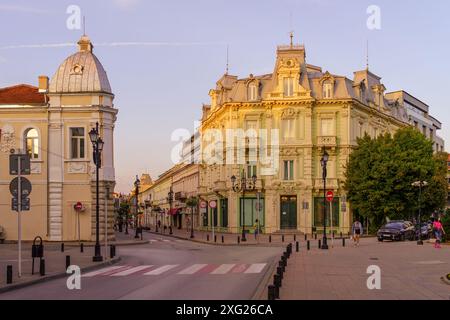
198,43,444,233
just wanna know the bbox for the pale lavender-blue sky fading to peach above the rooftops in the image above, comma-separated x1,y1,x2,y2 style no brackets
0,0,450,192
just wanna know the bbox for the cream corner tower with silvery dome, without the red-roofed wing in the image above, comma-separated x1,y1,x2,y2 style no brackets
44,35,118,241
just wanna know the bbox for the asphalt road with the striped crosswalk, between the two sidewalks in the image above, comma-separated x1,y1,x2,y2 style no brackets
0,235,282,300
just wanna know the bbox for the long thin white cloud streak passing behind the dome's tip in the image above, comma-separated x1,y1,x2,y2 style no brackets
0,41,226,50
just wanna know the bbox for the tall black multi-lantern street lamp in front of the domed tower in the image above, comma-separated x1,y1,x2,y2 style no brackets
89,122,106,262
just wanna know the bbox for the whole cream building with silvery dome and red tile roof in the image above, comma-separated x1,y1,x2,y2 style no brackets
0,36,118,241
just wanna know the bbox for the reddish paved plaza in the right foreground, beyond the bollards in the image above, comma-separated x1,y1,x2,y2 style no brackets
280,239,450,300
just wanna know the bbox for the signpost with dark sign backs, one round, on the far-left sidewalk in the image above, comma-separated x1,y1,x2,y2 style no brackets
9,154,32,278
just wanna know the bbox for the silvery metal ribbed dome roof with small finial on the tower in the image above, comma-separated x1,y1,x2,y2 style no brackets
49,36,112,94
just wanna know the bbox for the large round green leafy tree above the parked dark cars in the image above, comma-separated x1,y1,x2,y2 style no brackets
344,127,447,232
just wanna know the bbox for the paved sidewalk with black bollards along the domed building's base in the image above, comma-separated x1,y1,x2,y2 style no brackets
0,233,149,292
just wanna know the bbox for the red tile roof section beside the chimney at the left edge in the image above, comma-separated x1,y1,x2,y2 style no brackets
0,84,45,105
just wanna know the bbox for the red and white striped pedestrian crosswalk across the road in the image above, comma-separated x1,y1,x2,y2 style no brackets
82,263,267,278
